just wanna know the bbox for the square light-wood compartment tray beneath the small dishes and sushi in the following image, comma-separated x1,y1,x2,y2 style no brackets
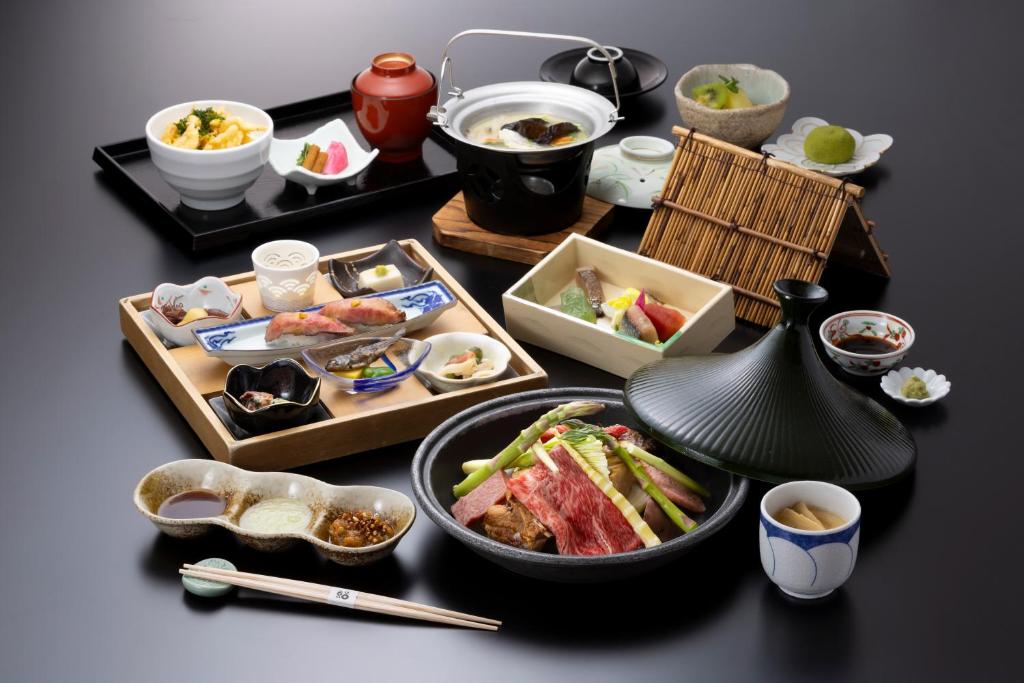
119,240,548,470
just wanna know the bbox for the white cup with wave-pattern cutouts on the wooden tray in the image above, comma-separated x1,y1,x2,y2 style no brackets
252,240,319,312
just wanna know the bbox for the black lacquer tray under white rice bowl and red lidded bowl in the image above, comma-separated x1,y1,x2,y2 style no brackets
92,90,458,251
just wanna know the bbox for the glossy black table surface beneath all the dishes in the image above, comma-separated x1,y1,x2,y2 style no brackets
0,0,1024,681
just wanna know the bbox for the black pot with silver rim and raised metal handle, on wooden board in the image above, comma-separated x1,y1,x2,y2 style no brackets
428,30,621,234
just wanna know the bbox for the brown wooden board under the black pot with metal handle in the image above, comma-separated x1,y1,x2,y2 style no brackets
434,193,615,264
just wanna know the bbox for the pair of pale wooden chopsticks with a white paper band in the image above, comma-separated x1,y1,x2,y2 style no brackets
178,564,501,631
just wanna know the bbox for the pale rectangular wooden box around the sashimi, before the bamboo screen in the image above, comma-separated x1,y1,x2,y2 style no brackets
502,234,735,377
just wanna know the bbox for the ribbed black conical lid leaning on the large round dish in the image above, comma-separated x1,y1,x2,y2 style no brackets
625,280,918,488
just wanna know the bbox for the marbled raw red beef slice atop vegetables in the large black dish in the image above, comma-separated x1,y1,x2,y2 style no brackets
508,446,643,555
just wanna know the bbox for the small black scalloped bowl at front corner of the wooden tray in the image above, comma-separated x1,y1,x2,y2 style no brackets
224,358,321,434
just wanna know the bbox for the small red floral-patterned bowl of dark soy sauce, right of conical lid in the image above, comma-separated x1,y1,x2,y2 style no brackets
818,310,914,377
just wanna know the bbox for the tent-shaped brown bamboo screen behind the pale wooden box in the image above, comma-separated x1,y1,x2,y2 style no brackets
639,126,889,326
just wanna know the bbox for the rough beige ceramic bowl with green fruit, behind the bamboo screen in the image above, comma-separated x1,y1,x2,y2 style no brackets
675,65,790,148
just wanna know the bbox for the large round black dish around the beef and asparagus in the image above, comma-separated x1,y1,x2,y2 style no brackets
413,387,748,583
